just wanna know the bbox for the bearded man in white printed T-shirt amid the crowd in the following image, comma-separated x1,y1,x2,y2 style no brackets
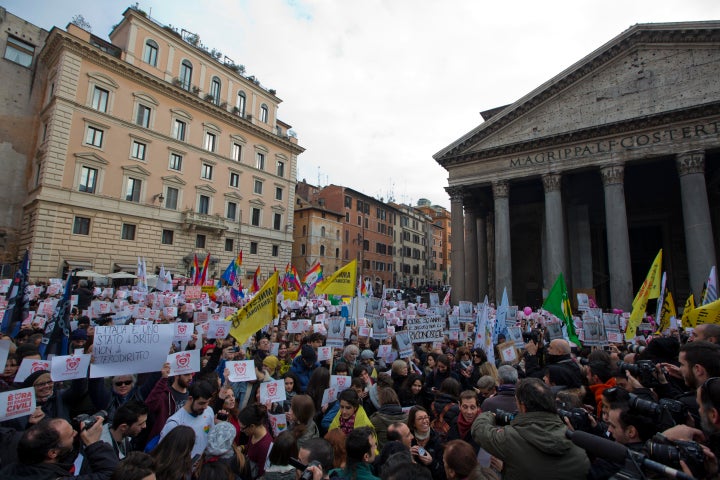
160,380,215,457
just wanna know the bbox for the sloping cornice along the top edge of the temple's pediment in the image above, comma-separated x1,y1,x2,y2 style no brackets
433,22,720,167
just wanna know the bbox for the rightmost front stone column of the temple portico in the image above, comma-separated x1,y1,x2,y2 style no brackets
677,151,716,302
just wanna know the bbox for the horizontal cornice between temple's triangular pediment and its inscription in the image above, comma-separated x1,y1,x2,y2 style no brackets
437,102,720,168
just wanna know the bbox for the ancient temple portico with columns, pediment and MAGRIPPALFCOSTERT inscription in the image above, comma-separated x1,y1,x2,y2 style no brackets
434,22,720,309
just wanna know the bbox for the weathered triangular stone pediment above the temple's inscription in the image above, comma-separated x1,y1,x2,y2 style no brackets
434,22,720,165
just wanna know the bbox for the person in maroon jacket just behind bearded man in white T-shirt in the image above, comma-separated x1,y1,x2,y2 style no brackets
145,363,192,438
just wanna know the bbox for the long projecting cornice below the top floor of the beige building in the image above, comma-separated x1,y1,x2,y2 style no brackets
40,29,305,155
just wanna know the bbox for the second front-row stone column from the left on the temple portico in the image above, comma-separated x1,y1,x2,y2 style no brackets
493,181,513,304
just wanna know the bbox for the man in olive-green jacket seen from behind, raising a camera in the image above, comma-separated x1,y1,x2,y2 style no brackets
472,378,590,480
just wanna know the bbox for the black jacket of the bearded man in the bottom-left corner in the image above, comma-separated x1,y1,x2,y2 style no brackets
0,441,118,480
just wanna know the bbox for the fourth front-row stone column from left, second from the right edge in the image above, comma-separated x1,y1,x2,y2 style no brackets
600,165,633,311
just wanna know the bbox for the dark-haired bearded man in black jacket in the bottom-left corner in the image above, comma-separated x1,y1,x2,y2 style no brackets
0,417,118,480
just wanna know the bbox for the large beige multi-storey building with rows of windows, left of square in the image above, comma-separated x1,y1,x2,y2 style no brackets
12,7,303,279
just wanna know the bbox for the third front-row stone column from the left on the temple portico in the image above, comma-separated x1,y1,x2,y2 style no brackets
542,173,569,291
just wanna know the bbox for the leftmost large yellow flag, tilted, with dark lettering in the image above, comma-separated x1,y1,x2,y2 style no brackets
225,272,278,344
